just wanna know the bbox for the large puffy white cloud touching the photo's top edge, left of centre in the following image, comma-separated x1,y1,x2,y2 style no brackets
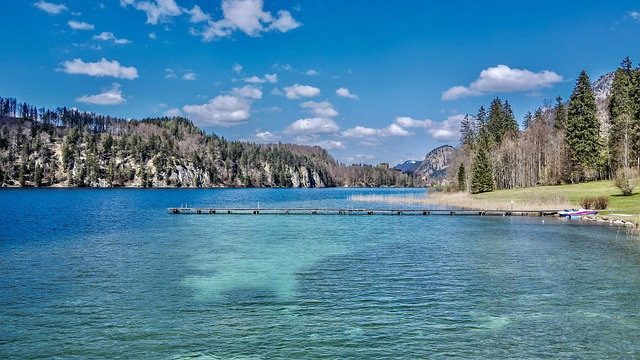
196,0,302,41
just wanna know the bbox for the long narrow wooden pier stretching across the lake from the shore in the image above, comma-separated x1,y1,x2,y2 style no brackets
168,207,558,216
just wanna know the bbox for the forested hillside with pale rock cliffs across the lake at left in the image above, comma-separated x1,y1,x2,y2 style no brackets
0,98,413,187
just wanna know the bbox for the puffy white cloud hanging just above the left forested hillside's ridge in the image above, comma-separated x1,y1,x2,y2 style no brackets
182,95,251,126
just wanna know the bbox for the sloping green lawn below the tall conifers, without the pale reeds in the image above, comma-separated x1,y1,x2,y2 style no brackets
471,181,640,217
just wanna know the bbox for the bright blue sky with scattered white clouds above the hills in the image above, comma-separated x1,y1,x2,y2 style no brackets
0,0,640,164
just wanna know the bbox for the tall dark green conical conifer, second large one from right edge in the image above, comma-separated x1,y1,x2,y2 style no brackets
565,70,601,182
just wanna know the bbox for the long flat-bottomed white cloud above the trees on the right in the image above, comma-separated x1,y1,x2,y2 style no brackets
442,65,564,100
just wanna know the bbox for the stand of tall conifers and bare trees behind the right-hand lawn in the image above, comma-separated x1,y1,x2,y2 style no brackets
451,57,640,195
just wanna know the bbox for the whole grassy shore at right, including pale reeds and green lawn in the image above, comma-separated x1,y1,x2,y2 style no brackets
353,181,640,224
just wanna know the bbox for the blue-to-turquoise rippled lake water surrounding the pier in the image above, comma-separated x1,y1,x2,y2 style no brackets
0,189,640,359
